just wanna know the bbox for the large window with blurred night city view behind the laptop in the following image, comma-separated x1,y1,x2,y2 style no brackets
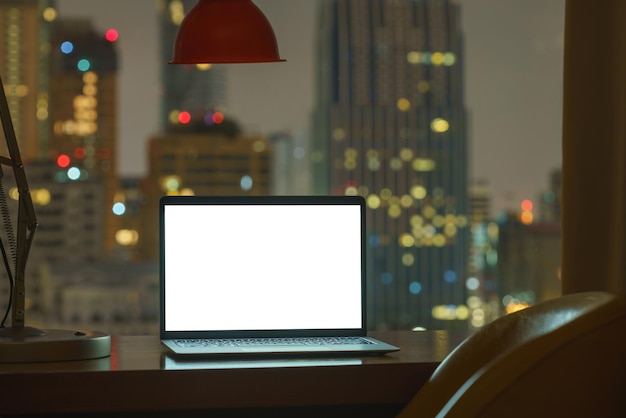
0,0,564,332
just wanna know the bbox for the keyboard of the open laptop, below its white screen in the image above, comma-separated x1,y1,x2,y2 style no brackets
174,337,374,347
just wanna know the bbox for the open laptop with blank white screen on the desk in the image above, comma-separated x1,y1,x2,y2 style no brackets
159,196,398,357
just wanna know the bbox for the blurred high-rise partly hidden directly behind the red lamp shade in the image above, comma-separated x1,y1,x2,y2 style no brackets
159,0,226,132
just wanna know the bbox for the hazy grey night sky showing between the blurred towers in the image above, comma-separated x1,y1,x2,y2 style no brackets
57,0,564,211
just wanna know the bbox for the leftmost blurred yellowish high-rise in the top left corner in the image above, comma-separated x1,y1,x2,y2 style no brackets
0,0,56,161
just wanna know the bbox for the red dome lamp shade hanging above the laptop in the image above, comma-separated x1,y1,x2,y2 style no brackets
170,0,284,64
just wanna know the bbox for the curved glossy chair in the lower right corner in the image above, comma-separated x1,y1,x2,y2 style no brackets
399,292,626,418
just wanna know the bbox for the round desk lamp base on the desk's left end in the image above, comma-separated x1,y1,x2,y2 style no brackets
0,327,111,363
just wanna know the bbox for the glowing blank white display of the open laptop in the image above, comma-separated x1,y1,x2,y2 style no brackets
164,204,363,331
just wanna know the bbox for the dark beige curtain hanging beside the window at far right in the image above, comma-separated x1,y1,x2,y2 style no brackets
562,0,626,294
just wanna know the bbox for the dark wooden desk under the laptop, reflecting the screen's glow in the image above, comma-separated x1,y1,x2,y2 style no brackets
0,331,469,417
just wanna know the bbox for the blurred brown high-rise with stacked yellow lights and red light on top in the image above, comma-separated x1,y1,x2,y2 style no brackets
47,19,118,257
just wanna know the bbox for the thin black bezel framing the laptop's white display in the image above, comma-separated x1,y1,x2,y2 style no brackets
159,196,367,339
